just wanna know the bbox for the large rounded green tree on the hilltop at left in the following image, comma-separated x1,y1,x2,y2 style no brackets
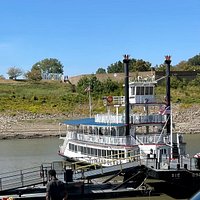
31,58,63,74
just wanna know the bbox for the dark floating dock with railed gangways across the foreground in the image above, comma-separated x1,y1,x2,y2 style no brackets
0,157,200,199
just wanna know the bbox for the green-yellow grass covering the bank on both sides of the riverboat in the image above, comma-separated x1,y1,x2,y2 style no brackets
0,81,200,115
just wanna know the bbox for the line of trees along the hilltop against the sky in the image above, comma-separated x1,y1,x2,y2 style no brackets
0,54,200,81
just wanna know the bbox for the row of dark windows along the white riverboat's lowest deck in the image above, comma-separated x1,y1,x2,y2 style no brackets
69,143,137,158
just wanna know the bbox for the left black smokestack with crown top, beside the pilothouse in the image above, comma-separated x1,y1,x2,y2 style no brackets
123,55,130,136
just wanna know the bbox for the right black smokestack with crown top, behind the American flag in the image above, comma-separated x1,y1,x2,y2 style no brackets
165,56,172,134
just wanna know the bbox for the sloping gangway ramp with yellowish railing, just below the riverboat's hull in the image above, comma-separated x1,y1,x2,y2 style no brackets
73,161,140,180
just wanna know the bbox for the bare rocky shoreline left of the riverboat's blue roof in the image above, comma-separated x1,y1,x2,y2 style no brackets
0,113,69,140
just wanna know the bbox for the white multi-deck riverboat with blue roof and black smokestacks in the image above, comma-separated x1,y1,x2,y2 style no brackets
59,55,186,166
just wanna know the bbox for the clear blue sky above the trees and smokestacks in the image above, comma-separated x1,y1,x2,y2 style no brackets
0,0,200,77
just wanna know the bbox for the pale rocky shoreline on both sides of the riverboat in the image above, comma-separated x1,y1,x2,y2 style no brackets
0,105,200,140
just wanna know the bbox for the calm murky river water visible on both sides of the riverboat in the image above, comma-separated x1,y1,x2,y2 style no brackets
0,134,200,173
